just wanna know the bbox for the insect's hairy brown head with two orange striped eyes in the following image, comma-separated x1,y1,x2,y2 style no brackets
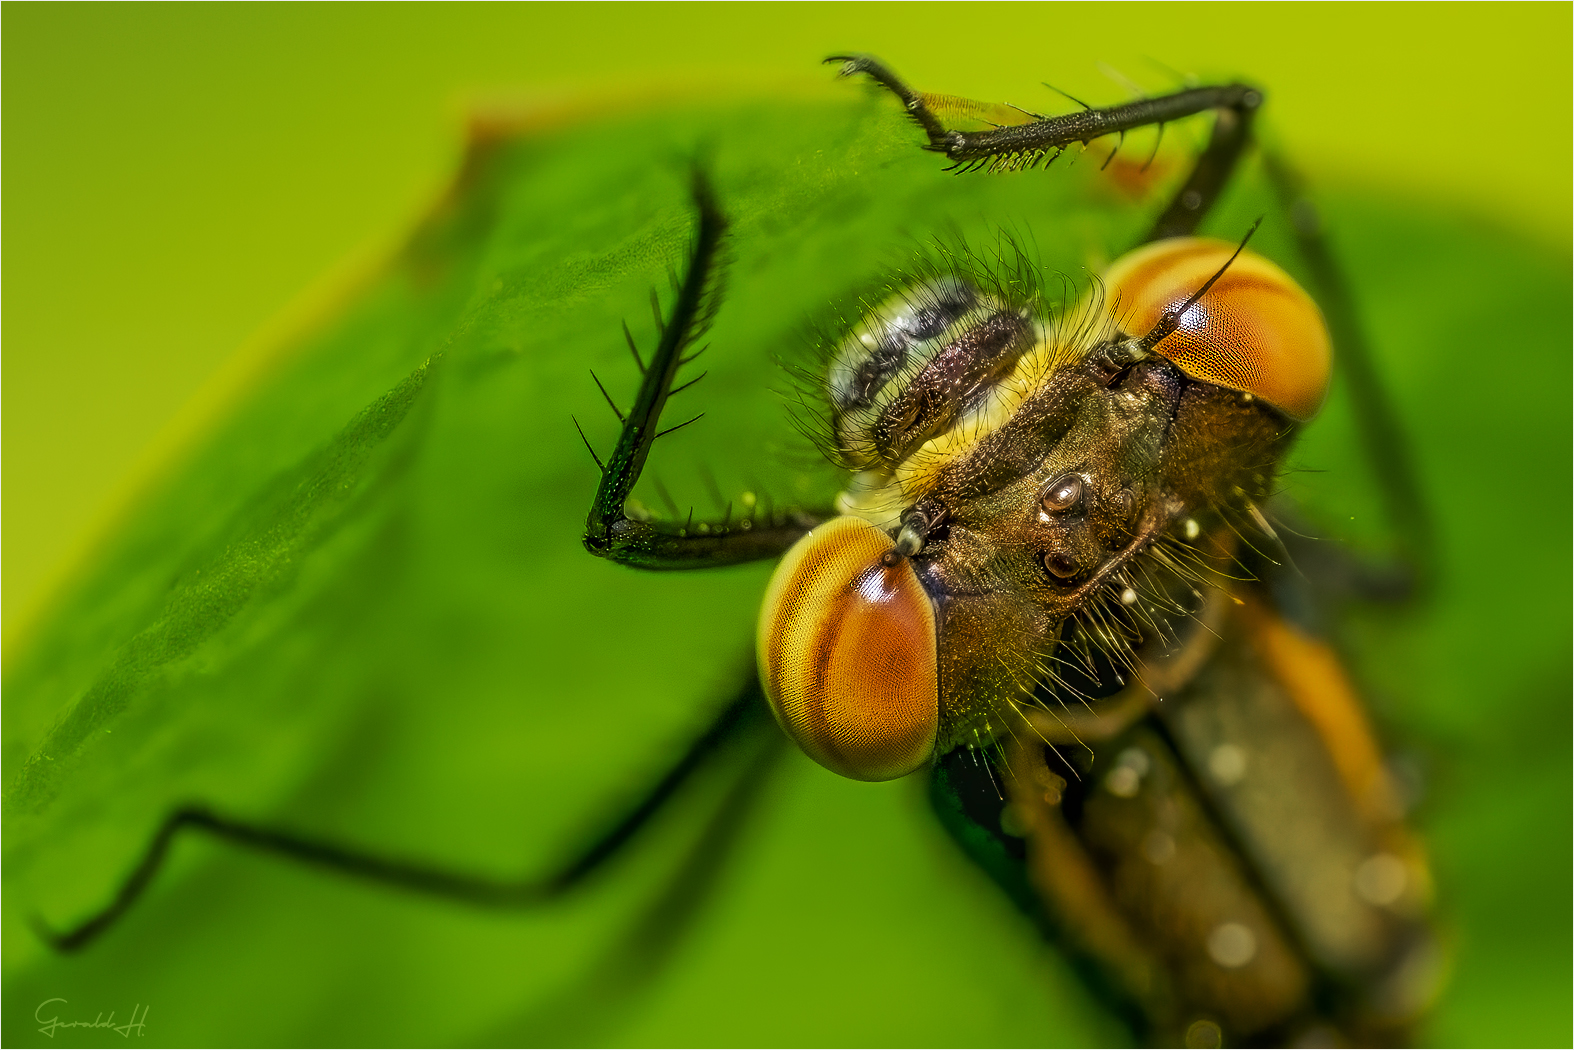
759,238,1328,779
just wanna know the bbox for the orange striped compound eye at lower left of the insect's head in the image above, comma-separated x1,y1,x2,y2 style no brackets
757,518,940,781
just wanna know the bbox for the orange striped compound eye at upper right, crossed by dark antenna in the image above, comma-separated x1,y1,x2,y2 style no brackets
1105,238,1332,420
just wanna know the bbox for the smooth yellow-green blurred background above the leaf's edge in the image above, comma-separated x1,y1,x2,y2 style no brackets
0,3,1569,650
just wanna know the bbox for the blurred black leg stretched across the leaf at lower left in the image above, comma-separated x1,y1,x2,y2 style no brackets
33,674,774,952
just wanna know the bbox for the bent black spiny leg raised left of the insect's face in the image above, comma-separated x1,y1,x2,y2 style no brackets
581,172,823,570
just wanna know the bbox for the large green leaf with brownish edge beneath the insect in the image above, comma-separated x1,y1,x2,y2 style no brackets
5,92,1569,1045
